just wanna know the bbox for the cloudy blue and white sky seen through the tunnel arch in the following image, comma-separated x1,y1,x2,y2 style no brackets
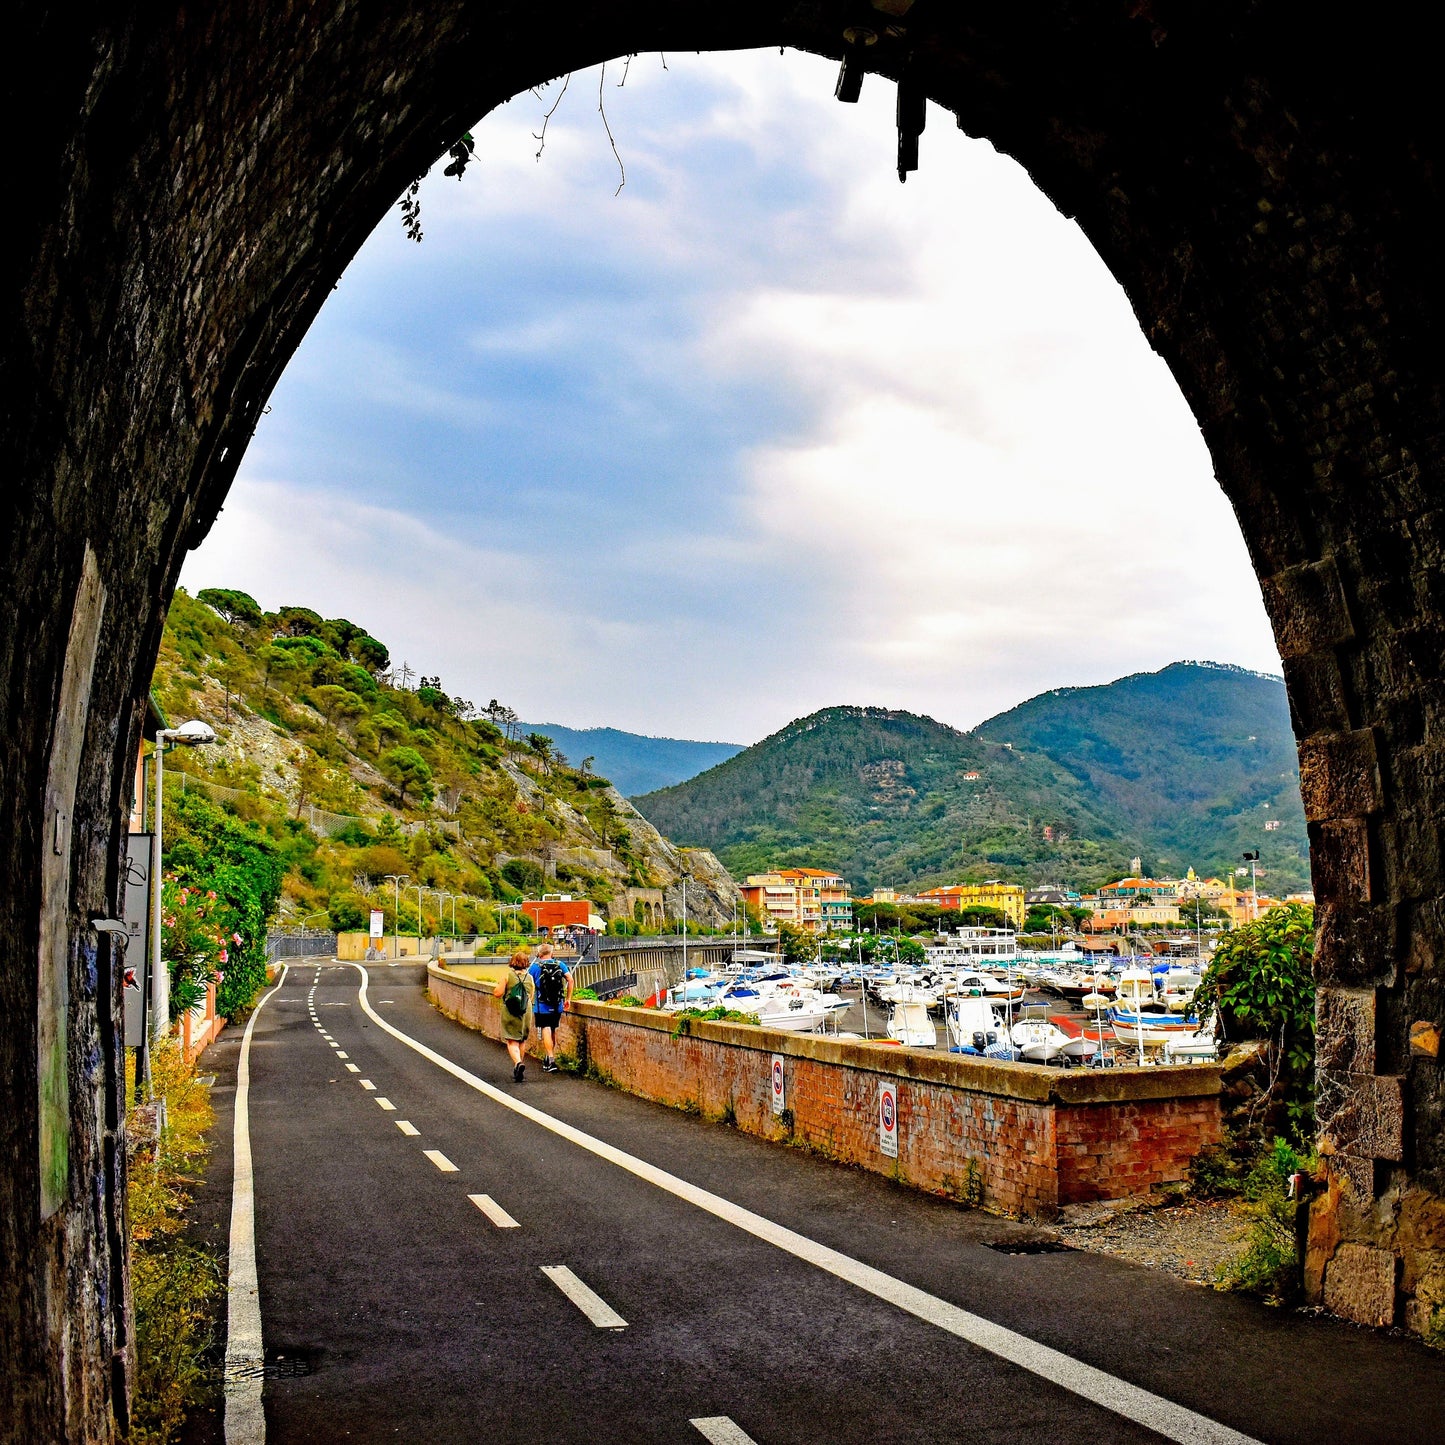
182,51,1279,743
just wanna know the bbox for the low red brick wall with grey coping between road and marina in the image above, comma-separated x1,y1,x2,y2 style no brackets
428,967,1221,1220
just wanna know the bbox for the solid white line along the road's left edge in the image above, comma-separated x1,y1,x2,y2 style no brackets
224,964,288,1445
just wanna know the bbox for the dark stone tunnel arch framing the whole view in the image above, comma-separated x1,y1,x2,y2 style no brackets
0,0,1445,1439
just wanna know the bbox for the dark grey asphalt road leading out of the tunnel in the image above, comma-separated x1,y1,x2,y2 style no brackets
202,962,1445,1445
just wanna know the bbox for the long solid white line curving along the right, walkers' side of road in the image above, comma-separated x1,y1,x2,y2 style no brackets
351,964,1257,1445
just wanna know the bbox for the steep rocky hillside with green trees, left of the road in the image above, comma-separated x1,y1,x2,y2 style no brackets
153,590,736,982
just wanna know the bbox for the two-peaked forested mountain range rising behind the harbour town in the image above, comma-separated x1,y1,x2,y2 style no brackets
634,663,1309,890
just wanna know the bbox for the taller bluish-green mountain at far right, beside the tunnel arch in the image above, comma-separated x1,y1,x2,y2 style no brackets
974,662,1309,892
